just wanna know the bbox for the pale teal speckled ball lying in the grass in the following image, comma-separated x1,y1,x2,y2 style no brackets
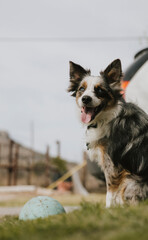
19,196,65,220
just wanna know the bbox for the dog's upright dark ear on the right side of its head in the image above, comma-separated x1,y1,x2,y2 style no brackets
100,59,122,84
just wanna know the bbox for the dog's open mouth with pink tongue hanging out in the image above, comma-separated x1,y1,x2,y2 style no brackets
81,104,103,123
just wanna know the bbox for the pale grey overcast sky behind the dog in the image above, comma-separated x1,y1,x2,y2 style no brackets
0,0,148,162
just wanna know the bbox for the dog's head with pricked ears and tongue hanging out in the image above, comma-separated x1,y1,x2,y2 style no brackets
68,59,122,124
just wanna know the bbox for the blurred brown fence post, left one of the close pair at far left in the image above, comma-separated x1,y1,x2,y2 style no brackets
8,140,14,186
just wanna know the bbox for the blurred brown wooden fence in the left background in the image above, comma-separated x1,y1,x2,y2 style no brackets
0,140,57,186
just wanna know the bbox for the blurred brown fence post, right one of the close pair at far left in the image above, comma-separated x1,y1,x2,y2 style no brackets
13,144,19,185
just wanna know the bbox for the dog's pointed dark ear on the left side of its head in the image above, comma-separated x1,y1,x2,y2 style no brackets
68,61,90,97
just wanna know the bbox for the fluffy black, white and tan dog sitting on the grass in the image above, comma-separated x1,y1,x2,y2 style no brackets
68,59,148,207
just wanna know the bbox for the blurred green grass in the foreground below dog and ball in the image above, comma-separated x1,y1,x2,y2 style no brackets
0,202,148,240
